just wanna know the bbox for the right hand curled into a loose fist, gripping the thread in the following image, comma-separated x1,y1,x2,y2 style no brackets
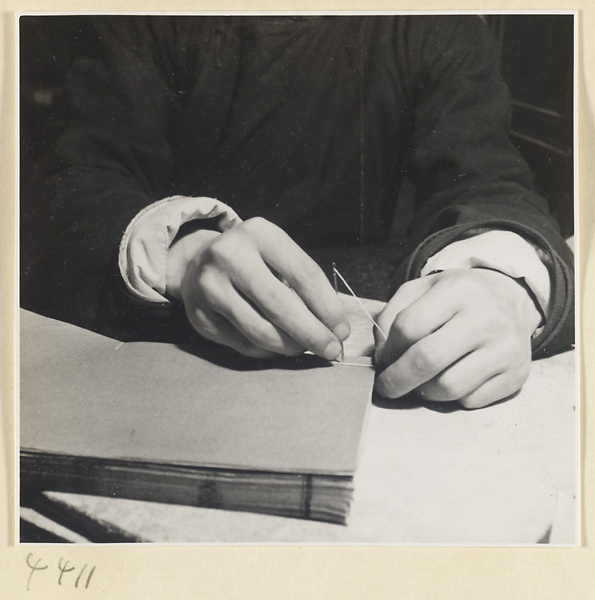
376,269,541,408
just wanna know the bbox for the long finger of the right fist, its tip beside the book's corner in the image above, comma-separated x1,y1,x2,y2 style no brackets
376,314,480,398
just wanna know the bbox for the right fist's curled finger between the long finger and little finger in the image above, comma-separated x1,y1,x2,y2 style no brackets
416,347,506,402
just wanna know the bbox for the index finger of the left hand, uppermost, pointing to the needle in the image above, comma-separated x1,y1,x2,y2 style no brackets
245,219,349,340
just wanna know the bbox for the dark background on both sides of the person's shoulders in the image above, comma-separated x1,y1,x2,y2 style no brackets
20,15,574,237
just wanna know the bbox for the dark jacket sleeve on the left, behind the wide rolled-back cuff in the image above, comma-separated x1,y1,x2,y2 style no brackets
21,17,193,339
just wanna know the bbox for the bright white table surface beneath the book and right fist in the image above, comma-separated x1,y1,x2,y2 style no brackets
21,302,579,545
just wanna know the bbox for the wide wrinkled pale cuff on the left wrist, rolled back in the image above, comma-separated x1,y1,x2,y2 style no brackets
118,196,241,302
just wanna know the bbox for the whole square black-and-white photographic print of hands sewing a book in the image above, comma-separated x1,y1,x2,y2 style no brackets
15,11,580,548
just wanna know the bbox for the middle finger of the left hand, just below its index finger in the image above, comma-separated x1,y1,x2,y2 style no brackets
232,247,341,360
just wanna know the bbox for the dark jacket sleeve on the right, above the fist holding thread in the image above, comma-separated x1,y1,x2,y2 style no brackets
397,16,574,357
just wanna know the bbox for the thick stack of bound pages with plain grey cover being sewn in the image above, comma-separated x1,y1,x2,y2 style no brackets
20,304,374,523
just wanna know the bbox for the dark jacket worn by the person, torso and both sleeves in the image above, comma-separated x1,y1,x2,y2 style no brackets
21,16,574,356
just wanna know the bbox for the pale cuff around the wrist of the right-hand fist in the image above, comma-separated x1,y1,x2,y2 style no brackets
421,231,551,316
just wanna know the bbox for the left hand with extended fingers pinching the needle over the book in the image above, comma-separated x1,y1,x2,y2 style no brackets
167,218,349,360
